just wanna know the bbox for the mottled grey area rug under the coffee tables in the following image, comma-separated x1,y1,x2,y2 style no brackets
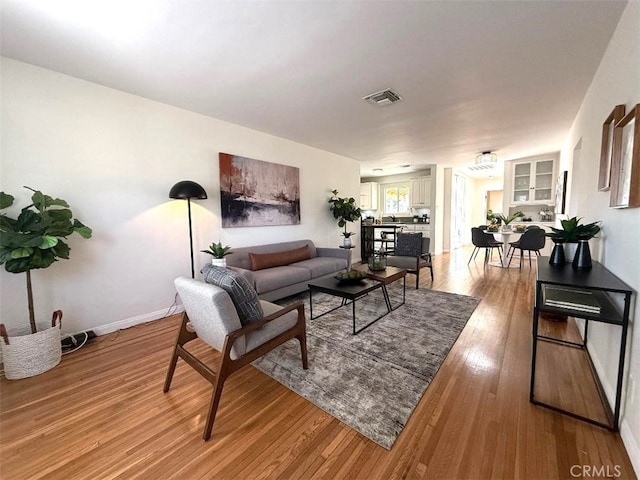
253,284,480,449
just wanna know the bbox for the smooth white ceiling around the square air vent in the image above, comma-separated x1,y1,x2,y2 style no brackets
0,0,626,176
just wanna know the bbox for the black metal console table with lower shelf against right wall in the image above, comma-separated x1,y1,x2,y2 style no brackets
529,257,633,431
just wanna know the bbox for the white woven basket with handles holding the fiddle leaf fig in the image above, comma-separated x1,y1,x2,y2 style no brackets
0,312,62,380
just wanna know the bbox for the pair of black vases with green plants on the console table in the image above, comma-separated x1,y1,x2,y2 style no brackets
546,217,601,268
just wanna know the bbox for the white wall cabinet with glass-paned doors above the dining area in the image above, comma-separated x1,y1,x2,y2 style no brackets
508,157,556,205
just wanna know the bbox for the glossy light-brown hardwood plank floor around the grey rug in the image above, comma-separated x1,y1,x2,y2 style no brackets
0,249,635,480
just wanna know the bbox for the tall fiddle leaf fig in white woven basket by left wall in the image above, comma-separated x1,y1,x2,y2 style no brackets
0,187,92,380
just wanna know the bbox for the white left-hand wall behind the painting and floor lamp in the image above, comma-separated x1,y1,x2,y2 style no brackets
0,58,360,332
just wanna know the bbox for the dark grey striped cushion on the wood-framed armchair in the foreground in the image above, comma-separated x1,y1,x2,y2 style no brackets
202,264,264,326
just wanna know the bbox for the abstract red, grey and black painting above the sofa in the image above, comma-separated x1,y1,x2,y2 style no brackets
219,153,300,228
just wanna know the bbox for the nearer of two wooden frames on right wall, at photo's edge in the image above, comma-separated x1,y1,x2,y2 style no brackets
609,104,640,208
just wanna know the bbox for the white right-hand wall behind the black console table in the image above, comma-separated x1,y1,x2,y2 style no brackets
559,2,640,474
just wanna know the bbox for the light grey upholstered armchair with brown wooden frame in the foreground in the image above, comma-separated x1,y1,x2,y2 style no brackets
163,276,307,441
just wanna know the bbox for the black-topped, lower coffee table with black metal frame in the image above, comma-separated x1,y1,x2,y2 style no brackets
309,277,392,335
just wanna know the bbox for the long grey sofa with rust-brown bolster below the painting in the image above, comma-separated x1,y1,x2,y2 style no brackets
225,240,350,301
